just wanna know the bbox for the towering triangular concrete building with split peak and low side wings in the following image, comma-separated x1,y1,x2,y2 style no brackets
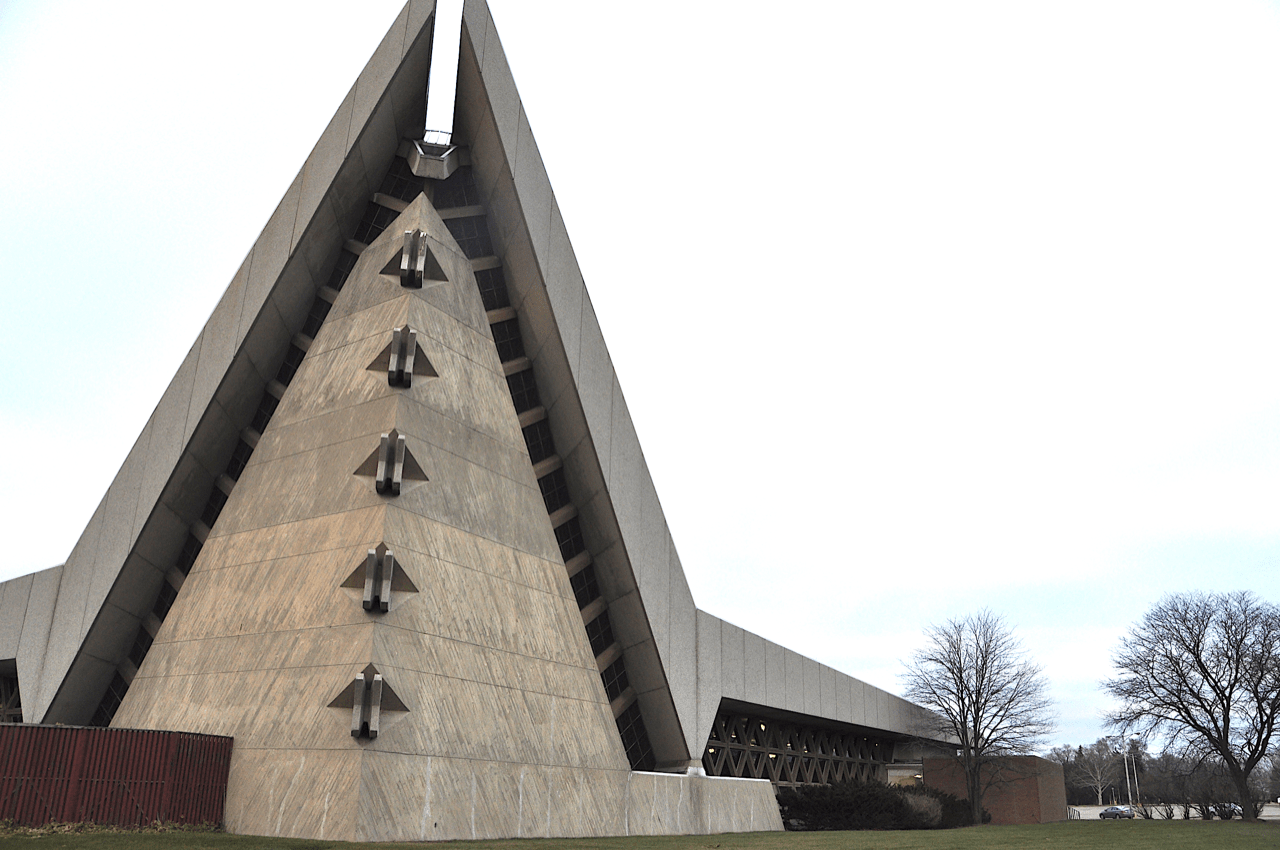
0,0,942,840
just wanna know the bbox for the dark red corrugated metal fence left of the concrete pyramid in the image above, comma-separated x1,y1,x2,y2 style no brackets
0,723,232,826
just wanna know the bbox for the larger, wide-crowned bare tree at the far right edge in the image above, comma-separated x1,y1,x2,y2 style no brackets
1105,593,1280,819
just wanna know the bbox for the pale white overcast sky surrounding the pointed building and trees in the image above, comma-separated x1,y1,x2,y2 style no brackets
0,0,1280,744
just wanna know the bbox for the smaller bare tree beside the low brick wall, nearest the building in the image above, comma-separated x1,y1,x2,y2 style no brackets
905,611,1053,823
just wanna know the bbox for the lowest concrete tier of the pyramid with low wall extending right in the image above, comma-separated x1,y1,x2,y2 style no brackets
227,750,782,841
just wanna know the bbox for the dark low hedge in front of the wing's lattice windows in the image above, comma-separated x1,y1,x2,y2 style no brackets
778,782,989,831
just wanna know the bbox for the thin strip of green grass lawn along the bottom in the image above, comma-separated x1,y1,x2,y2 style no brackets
0,821,1280,850
